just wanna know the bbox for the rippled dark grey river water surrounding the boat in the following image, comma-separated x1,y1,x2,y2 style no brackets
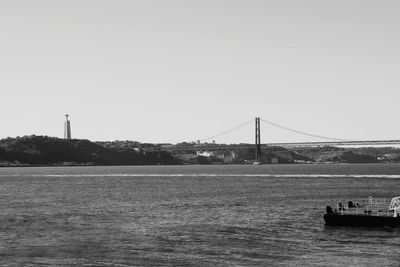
0,164,400,266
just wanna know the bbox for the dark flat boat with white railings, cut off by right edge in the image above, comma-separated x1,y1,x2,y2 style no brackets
324,197,400,227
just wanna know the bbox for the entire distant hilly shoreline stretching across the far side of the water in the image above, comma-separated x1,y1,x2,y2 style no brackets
0,136,400,166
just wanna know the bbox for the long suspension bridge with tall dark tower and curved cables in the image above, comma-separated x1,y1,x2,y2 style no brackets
162,117,400,157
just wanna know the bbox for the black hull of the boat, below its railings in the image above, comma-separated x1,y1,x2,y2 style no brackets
324,213,400,227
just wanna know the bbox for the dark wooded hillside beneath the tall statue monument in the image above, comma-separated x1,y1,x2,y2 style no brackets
0,135,180,166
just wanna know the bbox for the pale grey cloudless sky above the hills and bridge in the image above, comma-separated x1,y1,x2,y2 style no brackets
0,0,400,143
